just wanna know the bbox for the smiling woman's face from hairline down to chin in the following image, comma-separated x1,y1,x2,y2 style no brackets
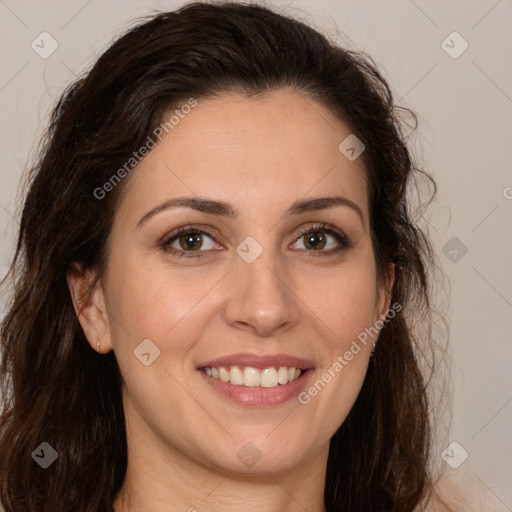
70,90,392,473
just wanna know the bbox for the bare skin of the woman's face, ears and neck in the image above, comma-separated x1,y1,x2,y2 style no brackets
68,90,394,512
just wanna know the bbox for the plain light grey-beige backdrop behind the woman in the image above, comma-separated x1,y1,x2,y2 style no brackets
0,0,512,512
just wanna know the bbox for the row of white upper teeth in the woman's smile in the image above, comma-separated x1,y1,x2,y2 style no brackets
204,366,301,388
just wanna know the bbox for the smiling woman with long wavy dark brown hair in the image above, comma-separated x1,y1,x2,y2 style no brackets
0,3,456,512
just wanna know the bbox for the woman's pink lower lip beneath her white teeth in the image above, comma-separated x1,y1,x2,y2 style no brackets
198,369,313,407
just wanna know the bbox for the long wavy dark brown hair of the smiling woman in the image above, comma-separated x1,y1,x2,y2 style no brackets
0,2,450,512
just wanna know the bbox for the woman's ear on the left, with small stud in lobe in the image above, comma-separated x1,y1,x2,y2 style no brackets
66,263,112,354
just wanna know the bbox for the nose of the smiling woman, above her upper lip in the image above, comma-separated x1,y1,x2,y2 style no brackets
225,251,300,336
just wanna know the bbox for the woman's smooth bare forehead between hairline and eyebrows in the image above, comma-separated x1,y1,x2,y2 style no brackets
118,90,367,224
